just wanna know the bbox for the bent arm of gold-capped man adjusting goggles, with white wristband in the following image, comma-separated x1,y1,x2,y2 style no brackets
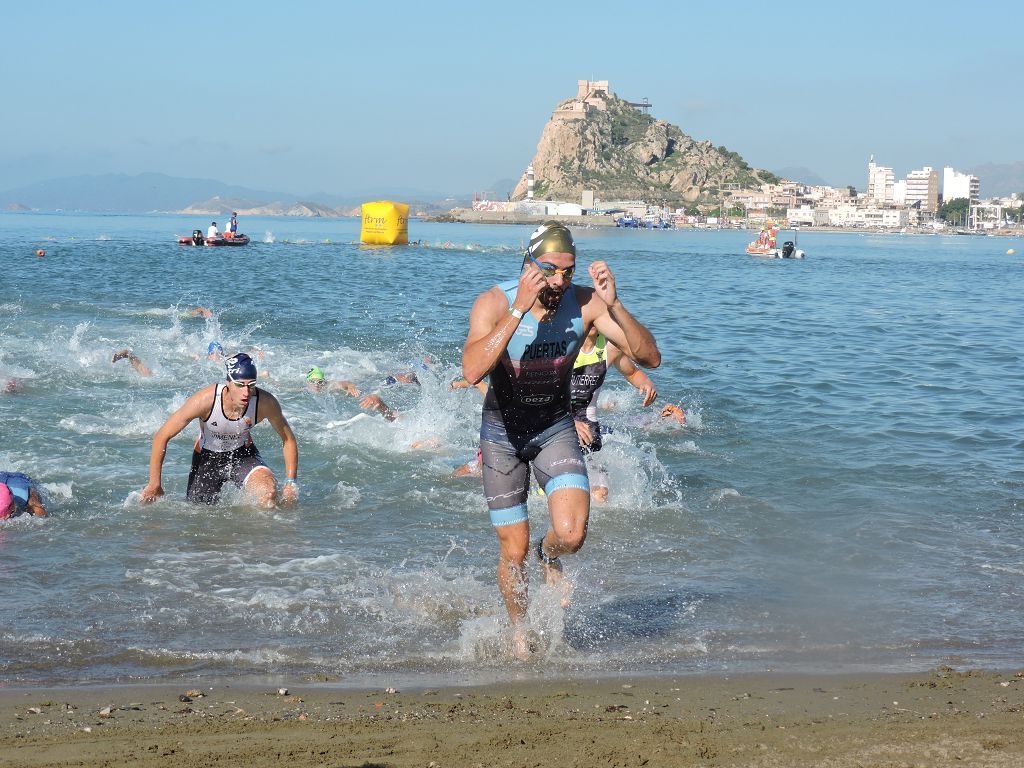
462,264,547,385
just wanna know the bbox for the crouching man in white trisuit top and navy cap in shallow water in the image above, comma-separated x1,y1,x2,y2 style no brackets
141,352,299,508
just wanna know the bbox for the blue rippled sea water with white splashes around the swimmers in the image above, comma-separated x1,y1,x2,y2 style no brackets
0,214,1024,685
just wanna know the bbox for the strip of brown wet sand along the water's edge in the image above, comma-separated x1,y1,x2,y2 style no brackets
0,668,1024,768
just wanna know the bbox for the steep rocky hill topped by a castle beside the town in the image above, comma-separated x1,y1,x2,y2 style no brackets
512,81,778,204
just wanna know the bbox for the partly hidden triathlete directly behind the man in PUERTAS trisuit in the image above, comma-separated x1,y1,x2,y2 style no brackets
569,327,657,504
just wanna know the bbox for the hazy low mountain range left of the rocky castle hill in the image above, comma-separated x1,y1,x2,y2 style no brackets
0,173,471,215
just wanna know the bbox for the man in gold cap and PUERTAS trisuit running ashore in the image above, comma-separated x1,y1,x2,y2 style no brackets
462,221,662,658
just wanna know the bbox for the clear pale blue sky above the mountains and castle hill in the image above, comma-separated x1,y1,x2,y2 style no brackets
0,0,1024,196
